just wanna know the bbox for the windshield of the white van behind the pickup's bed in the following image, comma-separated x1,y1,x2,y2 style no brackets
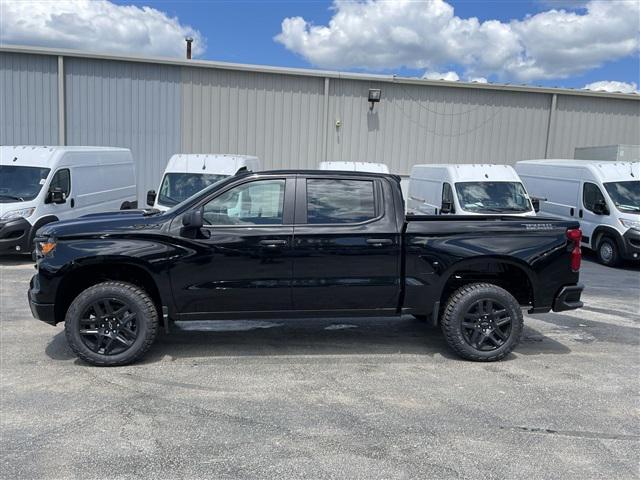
456,182,531,213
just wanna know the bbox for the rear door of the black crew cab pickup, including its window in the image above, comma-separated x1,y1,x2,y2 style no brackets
292,174,401,314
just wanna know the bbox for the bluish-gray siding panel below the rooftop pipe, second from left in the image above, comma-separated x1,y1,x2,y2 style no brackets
65,58,182,202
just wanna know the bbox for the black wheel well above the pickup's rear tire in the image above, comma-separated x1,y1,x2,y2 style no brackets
440,261,533,309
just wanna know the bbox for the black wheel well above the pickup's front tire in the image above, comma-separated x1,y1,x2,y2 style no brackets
54,264,162,323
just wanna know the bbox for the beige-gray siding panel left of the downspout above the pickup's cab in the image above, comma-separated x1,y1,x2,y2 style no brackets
182,67,324,169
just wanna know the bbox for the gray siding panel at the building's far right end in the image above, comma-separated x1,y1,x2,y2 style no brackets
549,95,640,158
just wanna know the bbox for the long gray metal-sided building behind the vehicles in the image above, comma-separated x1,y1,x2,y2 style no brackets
0,45,640,201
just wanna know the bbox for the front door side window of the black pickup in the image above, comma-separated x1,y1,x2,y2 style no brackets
203,179,285,225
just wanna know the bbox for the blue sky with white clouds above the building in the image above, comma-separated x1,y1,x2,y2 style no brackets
0,0,640,92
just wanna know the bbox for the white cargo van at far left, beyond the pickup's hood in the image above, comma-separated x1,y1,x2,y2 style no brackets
0,146,137,253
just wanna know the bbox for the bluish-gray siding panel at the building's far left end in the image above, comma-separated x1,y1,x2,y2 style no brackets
0,52,58,145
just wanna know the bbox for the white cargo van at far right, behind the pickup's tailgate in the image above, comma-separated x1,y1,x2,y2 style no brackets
516,159,640,266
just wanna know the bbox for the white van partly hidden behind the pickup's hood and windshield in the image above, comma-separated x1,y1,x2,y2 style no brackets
147,153,260,211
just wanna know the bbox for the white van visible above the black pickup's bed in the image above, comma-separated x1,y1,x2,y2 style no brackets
407,164,538,216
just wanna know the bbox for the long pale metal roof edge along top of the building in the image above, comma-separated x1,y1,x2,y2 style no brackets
0,44,640,101
